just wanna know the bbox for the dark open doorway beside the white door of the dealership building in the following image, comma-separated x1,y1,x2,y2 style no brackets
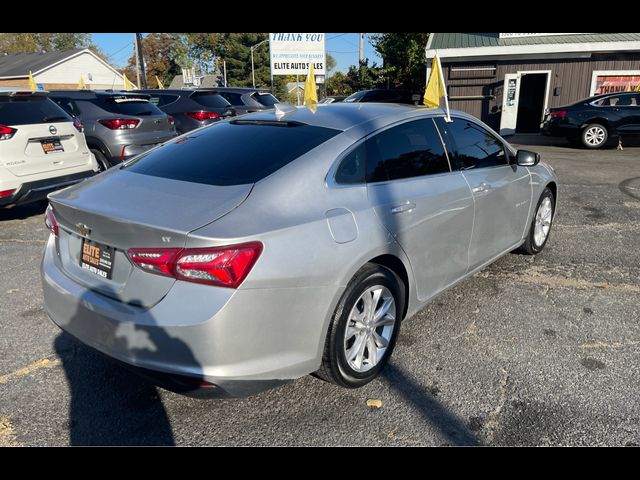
516,73,547,133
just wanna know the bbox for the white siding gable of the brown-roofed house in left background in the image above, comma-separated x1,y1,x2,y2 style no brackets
33,52,124,89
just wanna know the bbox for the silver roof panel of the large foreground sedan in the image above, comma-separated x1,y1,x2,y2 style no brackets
238,102,450,130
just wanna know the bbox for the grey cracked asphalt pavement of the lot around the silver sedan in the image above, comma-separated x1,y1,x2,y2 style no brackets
0,132,640,446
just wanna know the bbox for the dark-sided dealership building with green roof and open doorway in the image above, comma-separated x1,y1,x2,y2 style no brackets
426,33,640,135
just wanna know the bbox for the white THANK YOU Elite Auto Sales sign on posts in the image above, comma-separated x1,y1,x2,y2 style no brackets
269,33,326,75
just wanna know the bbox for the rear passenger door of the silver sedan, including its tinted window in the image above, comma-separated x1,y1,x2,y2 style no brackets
366,118,473,301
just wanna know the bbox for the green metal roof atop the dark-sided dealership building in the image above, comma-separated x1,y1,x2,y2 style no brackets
429,33,640,50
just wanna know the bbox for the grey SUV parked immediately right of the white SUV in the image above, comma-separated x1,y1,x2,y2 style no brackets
49,90,177,170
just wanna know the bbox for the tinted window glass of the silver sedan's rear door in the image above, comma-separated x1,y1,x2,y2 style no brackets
366,118,450,182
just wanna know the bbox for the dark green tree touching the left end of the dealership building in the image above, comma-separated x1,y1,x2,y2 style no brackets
372,33,429,93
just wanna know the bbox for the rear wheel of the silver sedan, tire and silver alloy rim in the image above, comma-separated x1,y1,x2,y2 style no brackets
315,263,404,388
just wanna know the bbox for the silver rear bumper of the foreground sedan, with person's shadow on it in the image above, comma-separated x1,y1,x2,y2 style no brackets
41,236,341,398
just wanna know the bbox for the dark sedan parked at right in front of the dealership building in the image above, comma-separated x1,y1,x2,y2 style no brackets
542,92,640,149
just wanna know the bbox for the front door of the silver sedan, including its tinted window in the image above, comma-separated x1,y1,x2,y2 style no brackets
438,117,532,270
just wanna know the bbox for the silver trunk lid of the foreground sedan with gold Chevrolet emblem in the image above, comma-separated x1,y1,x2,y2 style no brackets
49,169,253,307
